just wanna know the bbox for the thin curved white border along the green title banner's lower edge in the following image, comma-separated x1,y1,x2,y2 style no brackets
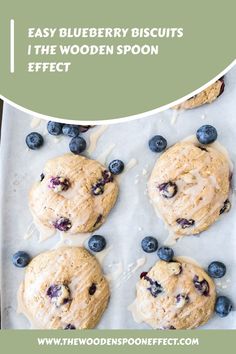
0,59,236,125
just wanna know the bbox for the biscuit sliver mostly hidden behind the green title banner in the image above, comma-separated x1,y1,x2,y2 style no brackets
173,78,225,109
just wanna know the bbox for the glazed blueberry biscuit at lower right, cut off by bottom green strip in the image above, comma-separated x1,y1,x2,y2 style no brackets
131,259,216,329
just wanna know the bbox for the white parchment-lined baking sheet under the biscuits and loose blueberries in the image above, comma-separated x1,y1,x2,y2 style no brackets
1,67,236,329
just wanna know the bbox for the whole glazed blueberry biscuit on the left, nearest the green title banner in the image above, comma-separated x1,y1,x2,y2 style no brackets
29,154,118,234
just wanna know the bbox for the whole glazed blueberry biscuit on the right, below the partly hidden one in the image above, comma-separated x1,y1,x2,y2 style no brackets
148,141,231,238
